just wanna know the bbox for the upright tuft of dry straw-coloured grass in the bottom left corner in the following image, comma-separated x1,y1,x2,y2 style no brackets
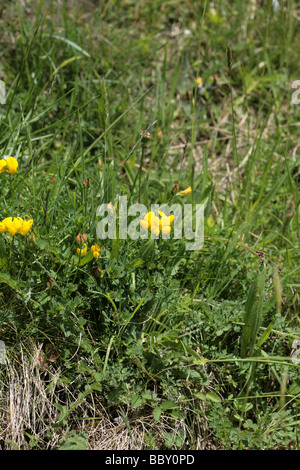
0,345,59,449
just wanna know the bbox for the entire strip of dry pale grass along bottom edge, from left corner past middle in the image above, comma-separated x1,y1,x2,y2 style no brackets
0,342,215,450
